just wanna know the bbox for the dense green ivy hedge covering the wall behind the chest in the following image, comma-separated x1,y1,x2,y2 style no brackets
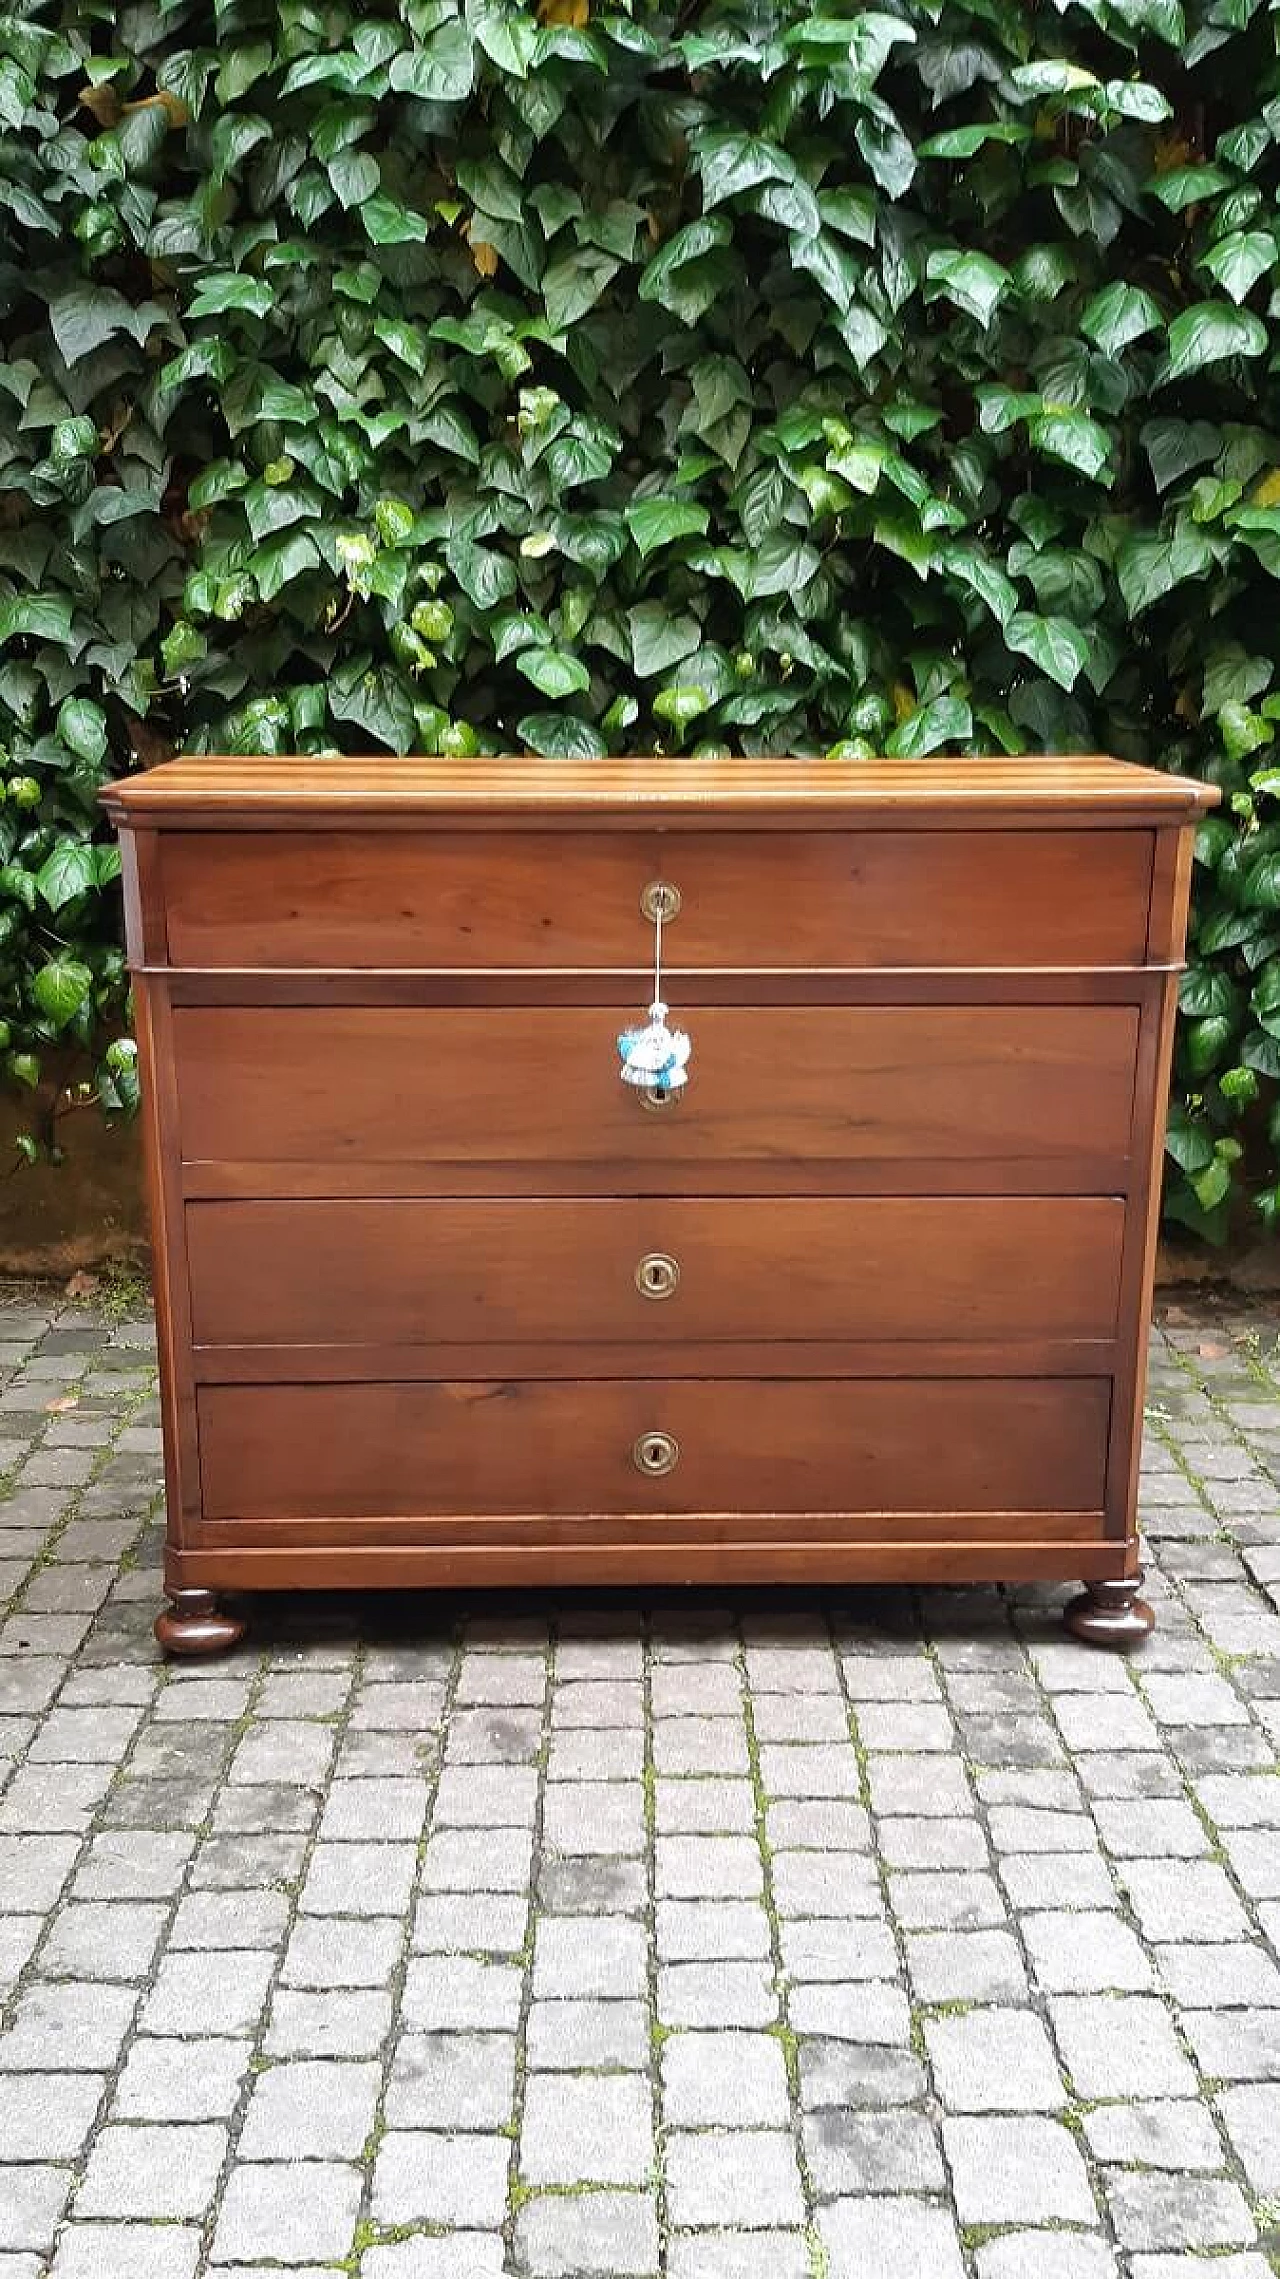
0,0,1280,1235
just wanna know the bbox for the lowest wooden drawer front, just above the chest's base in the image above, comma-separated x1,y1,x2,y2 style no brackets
198,1377,1111,1520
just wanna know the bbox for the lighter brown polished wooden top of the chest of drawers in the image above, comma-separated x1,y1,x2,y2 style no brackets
102,754,1219,827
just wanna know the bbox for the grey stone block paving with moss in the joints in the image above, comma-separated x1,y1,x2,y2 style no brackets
0,1290,1280,2279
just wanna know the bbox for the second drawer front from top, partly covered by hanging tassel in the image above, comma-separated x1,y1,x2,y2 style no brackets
173,1005,1137,1192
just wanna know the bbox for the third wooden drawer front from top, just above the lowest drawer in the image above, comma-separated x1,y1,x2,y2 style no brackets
187,1196,1123,1367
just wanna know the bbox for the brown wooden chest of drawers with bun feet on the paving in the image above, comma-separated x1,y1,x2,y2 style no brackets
107,759,1214,1652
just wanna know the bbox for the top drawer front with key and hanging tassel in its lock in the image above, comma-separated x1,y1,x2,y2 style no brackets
159,825,1152,975
